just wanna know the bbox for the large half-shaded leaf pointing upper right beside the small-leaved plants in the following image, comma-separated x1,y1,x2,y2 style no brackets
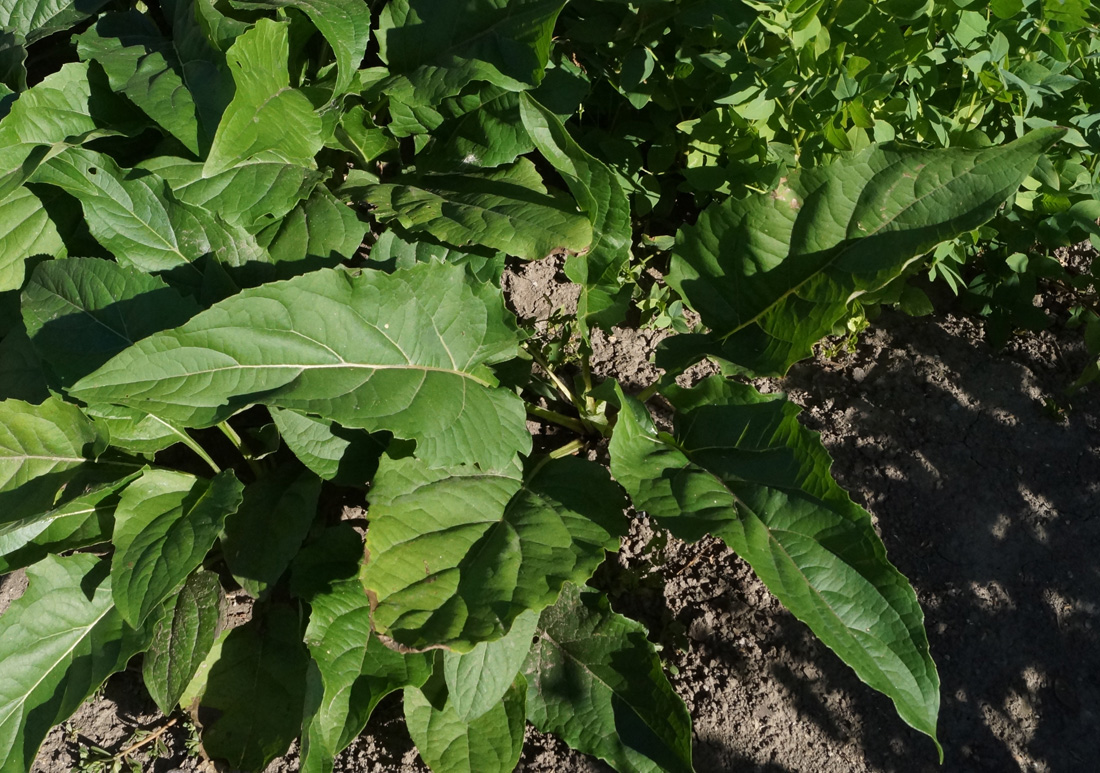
659,129,1064,375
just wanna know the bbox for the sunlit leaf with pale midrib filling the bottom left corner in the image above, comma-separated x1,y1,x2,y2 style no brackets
0,553,149,773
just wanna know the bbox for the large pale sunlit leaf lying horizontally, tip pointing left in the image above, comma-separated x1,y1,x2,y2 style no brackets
70,264,531,467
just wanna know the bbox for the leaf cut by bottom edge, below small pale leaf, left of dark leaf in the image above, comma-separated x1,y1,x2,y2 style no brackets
405,675,527,773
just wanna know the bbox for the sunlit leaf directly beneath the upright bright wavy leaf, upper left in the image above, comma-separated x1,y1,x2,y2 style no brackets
138,156,321,229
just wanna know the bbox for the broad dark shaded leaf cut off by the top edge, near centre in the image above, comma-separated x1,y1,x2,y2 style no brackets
377,0,565,103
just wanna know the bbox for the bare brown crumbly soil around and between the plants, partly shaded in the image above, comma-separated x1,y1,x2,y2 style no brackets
10,250,1100,773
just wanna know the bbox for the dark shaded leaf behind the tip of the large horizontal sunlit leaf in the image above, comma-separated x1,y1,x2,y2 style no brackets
22,257,199,387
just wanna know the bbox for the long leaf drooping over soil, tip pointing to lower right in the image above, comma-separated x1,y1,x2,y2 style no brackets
611,376,939,752
